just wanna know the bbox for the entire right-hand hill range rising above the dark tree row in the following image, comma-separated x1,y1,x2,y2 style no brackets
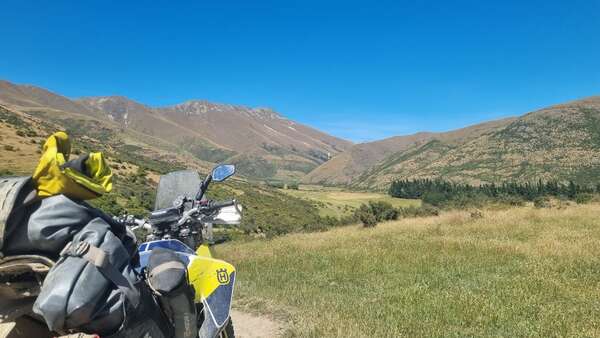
305,97,600,189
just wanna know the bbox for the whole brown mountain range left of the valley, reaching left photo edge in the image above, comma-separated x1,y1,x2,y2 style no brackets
0,81,351,180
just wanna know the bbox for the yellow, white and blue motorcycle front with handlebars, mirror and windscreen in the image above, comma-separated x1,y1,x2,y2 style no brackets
129,165,242,338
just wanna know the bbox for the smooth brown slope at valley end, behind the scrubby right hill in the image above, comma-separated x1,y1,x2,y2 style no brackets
303,119,513,186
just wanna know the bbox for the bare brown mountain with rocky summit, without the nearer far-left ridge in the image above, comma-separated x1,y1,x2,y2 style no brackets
79,97,351,179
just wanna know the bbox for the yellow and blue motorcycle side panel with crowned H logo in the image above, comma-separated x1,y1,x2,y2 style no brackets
188,247,235,338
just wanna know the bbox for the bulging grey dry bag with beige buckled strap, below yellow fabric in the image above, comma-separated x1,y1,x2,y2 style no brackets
33,218,140,335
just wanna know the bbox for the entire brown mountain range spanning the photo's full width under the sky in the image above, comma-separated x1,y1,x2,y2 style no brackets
0,80,600,190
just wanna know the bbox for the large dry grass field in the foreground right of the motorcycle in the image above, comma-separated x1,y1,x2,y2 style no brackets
215,204,600,337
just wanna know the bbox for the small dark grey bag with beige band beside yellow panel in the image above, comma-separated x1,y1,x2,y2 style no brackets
146,248,198,338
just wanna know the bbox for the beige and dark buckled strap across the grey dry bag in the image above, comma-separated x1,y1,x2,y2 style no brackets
60,241,140,307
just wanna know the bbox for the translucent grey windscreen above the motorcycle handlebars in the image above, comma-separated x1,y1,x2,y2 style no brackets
154,170,202,210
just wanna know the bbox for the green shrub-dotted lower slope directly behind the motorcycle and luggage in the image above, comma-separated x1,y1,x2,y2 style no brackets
0,105,338,236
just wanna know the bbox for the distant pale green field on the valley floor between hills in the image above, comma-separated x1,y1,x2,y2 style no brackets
280,186,421,218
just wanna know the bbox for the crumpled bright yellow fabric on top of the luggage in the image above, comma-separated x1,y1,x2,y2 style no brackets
32,131,112,200
